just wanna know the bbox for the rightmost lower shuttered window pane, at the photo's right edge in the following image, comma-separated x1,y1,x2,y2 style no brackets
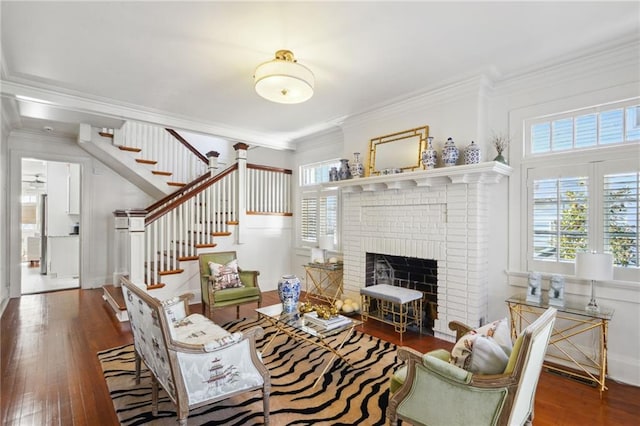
602,172,640,267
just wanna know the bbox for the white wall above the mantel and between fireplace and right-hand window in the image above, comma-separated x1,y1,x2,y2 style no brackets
295,42,640,385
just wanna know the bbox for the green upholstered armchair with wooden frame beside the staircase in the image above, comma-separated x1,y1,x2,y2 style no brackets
198,251,262,318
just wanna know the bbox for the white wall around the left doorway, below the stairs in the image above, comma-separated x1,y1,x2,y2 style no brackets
3,131,153,297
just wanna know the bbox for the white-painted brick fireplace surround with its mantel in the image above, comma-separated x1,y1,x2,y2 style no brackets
338,162,511,340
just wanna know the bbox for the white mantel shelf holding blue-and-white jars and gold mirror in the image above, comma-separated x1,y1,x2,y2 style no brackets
322,161,513,192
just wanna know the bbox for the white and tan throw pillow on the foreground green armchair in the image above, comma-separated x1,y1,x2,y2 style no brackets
449,318,512,374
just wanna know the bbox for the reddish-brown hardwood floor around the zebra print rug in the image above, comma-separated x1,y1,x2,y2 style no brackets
0,289,640,426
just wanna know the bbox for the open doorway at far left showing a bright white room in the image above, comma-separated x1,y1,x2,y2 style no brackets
20,158,80,294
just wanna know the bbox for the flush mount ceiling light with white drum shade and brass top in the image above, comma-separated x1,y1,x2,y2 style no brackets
253,50,315,104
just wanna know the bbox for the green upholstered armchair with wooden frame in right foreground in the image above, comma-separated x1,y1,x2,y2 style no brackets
387,308,556,426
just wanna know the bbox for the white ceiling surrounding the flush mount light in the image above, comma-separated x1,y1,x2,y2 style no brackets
0,1,640,147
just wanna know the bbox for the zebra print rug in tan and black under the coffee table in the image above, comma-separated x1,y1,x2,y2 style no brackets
98,318,398,426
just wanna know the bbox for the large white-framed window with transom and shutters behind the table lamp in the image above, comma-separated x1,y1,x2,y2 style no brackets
522,95,640,282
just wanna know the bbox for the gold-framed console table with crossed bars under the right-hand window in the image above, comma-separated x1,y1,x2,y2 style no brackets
506,295,613,398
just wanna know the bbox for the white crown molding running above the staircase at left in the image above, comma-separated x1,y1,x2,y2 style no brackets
0,79,295,150
